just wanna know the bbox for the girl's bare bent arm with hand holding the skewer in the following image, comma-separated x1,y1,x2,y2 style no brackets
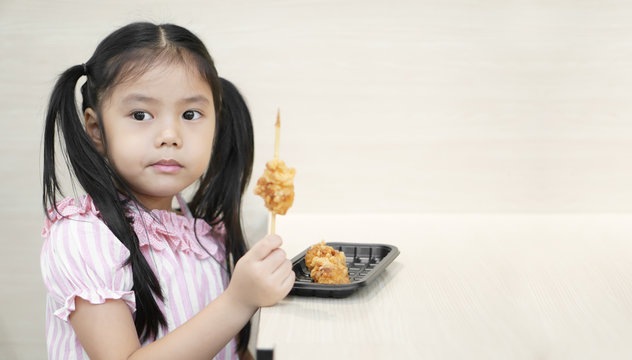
70,235,294,360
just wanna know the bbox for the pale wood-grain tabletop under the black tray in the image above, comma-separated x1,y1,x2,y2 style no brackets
256,214,632,360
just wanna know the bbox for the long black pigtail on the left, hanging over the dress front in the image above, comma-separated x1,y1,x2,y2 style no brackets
43,65,167,342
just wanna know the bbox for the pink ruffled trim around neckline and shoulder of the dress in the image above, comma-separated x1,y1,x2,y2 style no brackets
42,195,226,263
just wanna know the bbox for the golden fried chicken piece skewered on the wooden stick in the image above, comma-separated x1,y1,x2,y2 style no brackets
255,159,296,215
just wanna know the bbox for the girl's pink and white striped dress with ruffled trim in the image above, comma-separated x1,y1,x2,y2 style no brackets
41,196,238,359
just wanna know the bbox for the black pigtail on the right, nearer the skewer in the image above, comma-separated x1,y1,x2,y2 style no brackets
191,78,254,352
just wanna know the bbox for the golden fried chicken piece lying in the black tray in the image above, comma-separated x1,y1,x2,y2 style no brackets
305,241,350,284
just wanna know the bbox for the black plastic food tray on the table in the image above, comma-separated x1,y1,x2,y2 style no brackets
290,242,399,298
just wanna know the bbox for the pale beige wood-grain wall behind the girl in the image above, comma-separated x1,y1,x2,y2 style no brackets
0,0,632,359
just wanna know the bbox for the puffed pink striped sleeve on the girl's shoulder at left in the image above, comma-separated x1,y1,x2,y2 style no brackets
40,198,136,321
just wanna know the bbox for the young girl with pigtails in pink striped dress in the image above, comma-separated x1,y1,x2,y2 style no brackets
41,23,294,359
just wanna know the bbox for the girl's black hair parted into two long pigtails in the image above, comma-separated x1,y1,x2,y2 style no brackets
42,22,254,352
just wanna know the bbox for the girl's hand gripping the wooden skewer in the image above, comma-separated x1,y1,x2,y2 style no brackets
226,235,295,310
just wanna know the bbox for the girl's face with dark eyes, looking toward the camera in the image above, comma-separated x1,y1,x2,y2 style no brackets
85,63,215,210
